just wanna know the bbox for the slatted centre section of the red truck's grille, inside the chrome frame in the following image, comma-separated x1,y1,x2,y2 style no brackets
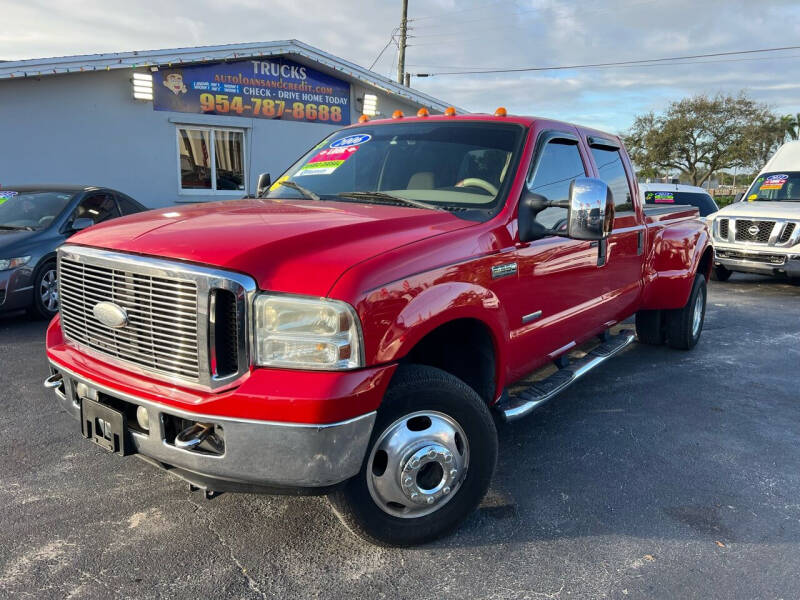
59,258,200,381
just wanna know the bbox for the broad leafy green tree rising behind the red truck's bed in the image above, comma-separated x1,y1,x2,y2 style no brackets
624,94,779,185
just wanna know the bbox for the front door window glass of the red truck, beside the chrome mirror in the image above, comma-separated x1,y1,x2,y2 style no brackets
528,140,586,229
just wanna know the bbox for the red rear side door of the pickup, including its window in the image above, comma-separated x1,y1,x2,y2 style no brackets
588,137,645,324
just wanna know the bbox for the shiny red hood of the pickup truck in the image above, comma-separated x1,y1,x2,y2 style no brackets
69,199,474,296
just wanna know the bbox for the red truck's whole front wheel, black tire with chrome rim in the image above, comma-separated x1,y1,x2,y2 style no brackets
328,365,497,546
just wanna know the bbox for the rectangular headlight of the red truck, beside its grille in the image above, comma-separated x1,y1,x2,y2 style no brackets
253,294,364,371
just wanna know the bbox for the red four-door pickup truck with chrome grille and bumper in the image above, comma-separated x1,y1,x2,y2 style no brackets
45,110,713,545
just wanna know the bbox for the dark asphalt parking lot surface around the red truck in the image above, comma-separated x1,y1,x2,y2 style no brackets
0,274,800,599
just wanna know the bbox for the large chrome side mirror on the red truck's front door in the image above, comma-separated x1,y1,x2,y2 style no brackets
567,177,614,240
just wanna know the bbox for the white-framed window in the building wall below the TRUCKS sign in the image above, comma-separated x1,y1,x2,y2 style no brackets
178,126,247,196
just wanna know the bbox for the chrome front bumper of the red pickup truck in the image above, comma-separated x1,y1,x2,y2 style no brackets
47,361,375,491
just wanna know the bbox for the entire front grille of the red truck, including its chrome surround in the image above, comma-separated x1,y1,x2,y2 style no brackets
58,246,255,389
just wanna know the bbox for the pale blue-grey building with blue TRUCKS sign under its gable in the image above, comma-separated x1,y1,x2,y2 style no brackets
0,40,456,208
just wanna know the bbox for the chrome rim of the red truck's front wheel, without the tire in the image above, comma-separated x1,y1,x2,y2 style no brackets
367,411,469,518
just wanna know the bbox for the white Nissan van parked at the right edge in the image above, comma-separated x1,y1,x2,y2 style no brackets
709,141,800,281
